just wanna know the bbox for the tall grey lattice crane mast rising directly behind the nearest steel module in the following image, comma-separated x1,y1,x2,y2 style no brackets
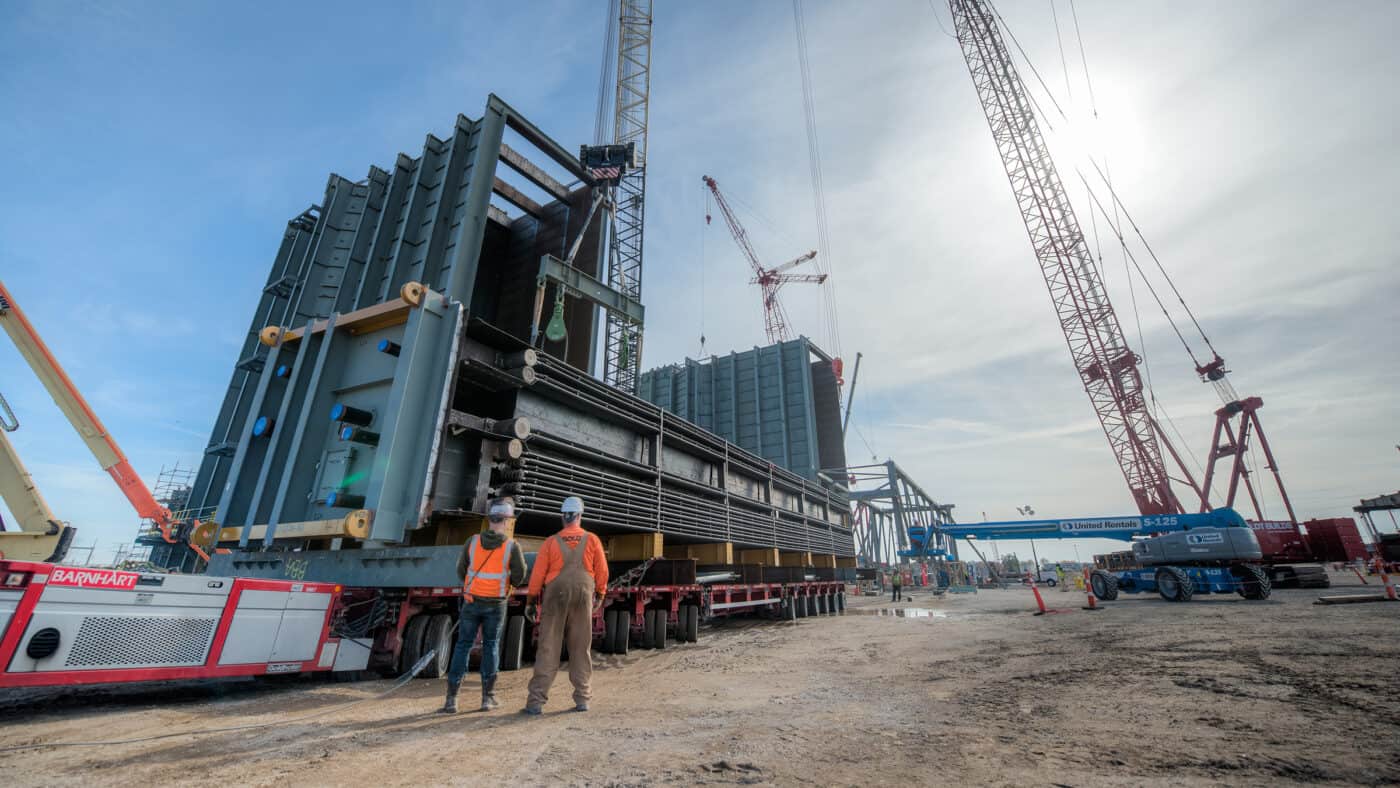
603,0,651,393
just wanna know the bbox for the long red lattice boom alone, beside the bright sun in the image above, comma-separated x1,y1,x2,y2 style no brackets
949,0,1184,515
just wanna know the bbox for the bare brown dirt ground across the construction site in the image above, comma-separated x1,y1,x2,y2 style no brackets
0,575,1400,785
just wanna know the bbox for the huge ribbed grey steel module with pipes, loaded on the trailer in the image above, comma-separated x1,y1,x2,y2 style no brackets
173,97,854,586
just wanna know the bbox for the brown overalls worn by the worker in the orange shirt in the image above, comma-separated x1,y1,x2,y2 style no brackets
525,536,596,708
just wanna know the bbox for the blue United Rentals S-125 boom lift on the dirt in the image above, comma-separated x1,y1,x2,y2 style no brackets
902,507,1271,602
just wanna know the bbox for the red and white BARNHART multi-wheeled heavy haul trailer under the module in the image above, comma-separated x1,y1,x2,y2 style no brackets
0,560,846,689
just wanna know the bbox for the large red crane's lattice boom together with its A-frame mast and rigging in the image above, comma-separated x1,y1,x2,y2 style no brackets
948,0,1298,523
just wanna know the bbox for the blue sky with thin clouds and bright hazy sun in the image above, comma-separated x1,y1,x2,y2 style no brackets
0,0,1400,568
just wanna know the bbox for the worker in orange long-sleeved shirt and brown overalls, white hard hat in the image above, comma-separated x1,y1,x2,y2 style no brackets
521,495,608,715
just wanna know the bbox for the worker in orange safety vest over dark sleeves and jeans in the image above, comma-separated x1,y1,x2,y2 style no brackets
440,498,525,714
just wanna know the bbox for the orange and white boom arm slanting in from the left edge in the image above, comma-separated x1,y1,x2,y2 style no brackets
0,283,209,561
